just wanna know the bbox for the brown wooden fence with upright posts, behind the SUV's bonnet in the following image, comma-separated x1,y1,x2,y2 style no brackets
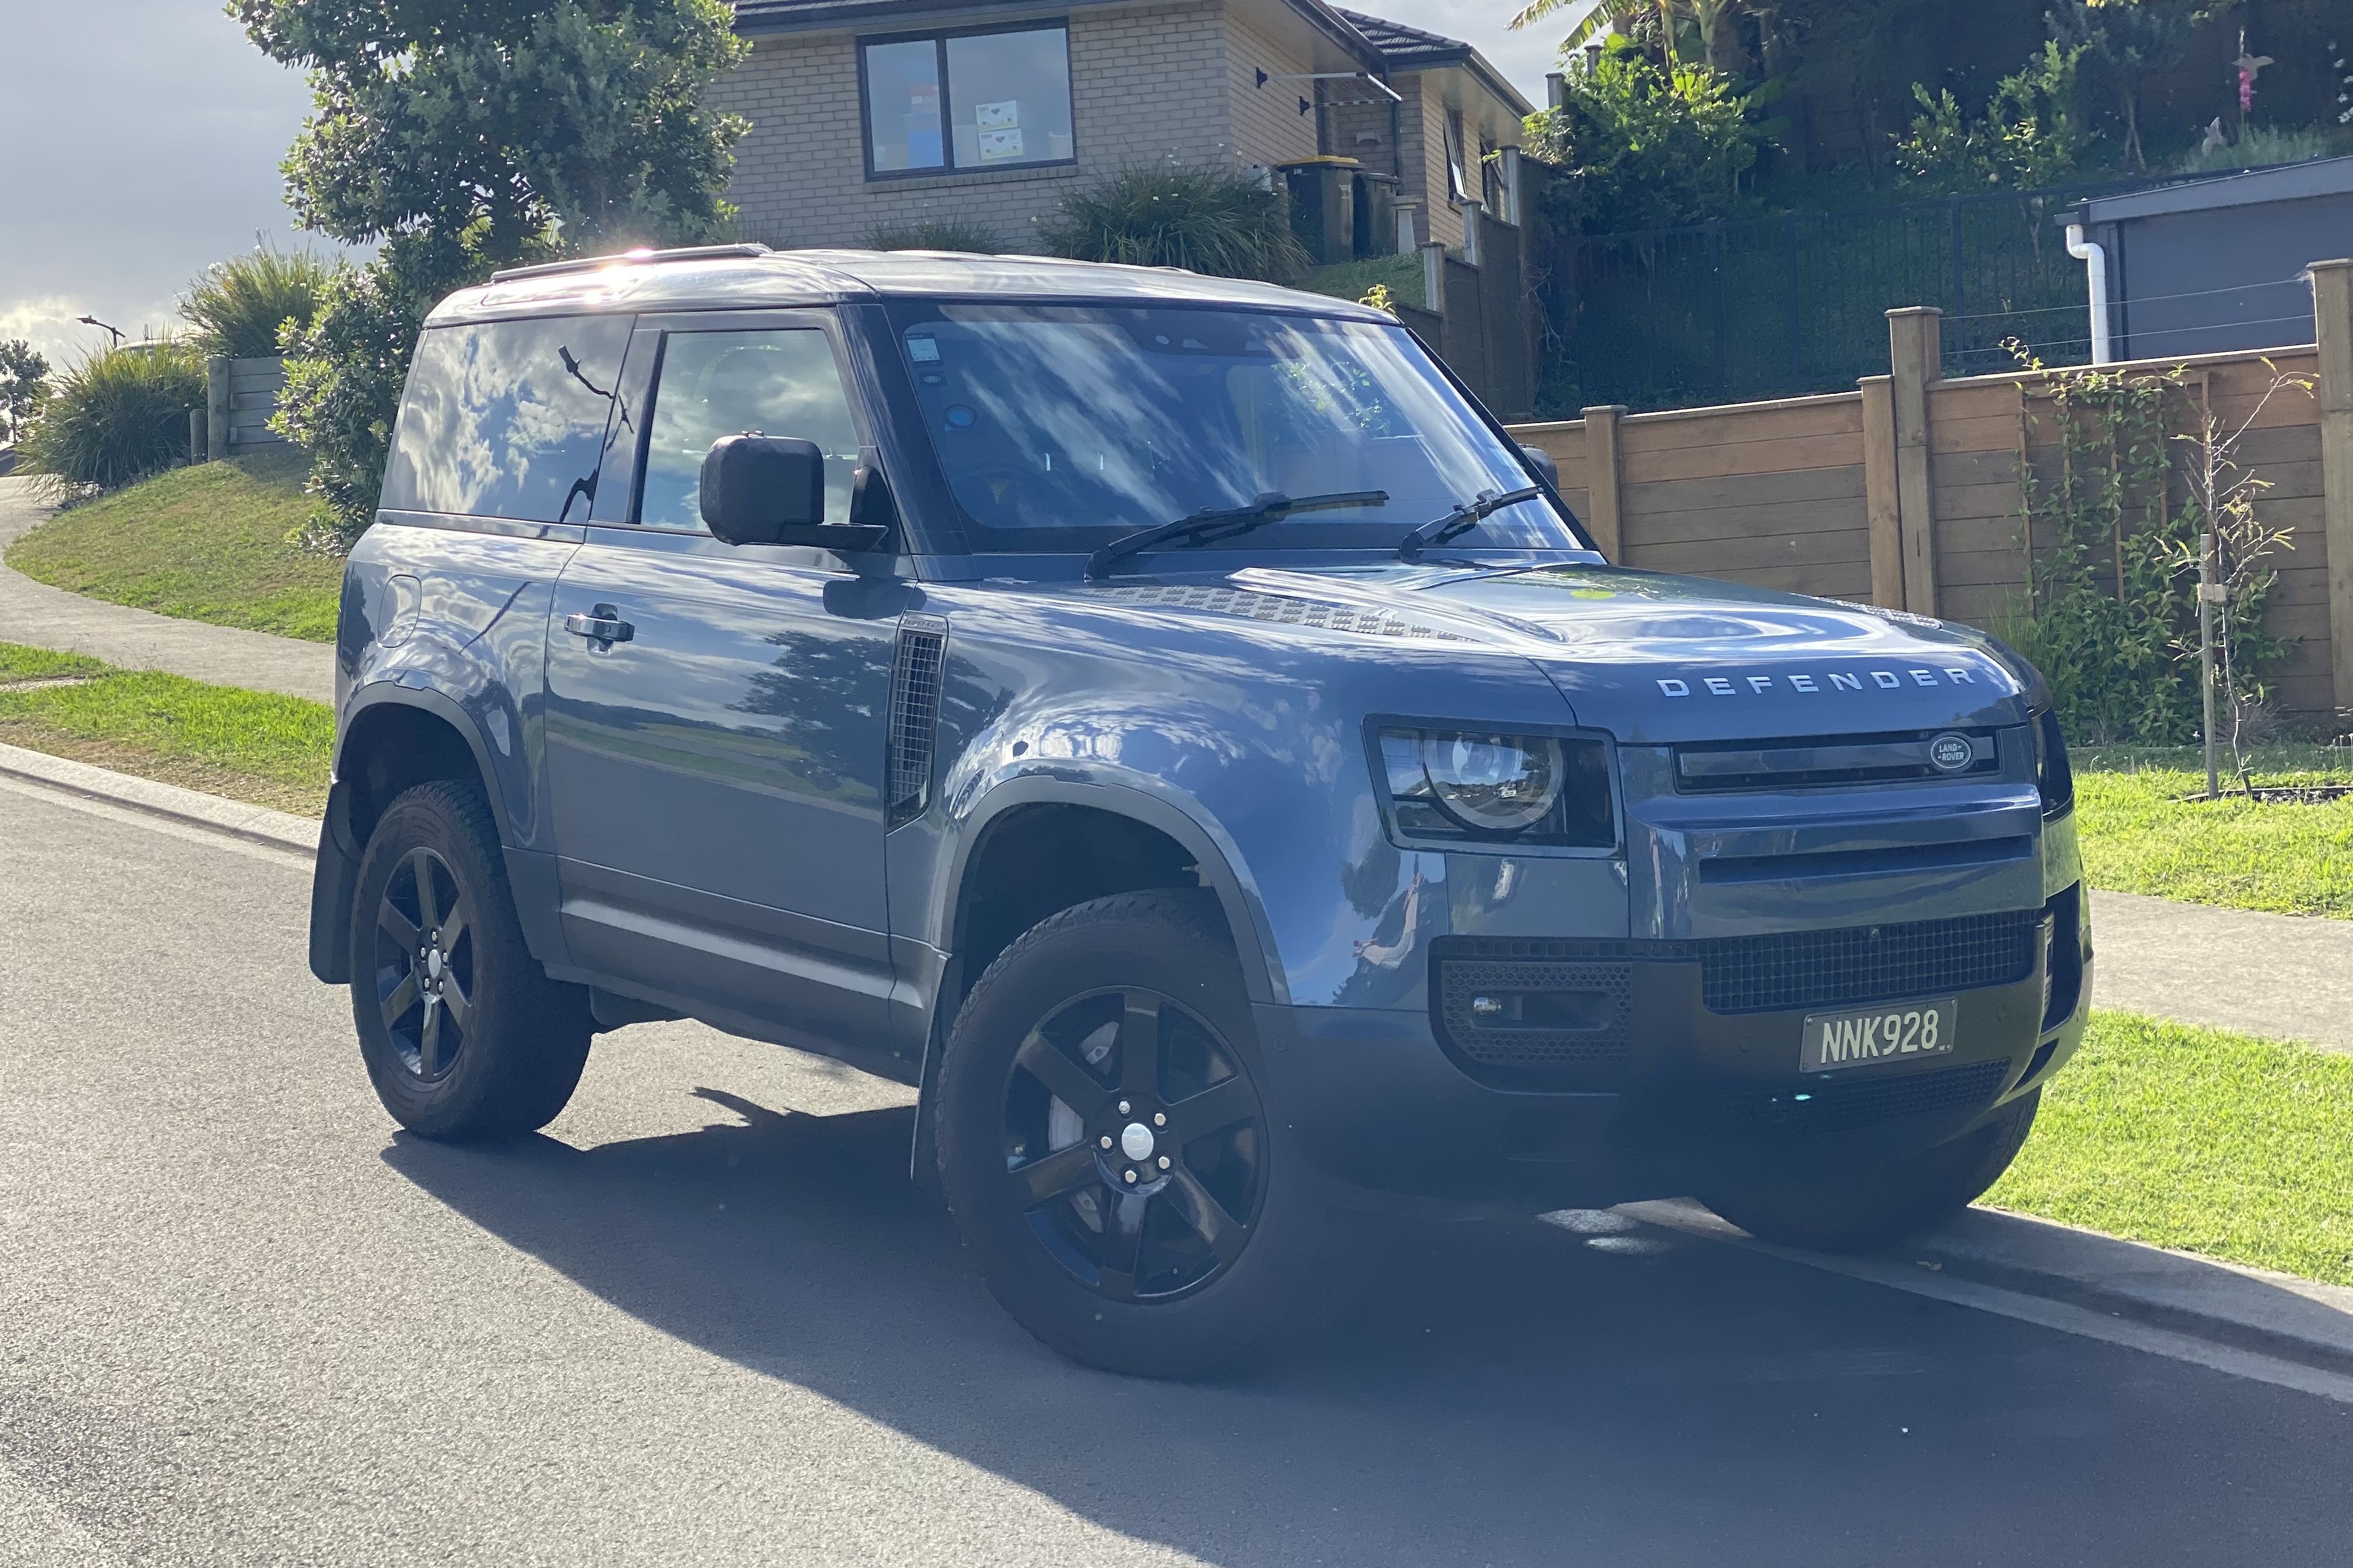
1513,261,2353,721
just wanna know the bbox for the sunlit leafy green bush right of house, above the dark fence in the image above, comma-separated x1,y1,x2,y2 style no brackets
1527,38,1772,233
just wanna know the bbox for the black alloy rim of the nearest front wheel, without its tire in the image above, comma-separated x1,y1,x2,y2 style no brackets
1005,989,1266,1302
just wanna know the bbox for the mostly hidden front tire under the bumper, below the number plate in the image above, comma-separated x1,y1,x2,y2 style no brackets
1701,1090,2043,1252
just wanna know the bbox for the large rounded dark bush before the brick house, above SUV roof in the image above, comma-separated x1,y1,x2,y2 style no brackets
1040,162,1315,282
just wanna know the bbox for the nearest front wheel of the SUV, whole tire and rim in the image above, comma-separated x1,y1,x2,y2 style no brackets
934,890,1360,1377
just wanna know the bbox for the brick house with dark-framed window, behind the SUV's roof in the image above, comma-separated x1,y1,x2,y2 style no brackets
713,0,1530,259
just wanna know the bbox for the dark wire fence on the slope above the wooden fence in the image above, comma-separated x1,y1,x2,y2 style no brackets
1544,179,2258,412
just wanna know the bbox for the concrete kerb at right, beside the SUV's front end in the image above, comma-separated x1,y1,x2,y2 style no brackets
1619,1199,2353,1375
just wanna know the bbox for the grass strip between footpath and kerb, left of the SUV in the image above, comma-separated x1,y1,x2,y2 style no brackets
0,642,334,817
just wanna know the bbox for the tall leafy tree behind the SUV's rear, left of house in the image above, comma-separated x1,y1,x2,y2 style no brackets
228,0,748,542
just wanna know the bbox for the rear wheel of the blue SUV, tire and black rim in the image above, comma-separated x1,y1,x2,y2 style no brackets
351,781,591,1142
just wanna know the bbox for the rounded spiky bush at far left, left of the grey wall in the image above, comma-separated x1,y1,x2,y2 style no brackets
16,339,205,490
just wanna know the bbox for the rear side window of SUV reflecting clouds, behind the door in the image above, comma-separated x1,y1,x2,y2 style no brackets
383,316,631,523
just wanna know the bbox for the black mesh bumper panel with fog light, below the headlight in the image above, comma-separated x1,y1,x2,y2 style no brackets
1438,958,1633,1090
